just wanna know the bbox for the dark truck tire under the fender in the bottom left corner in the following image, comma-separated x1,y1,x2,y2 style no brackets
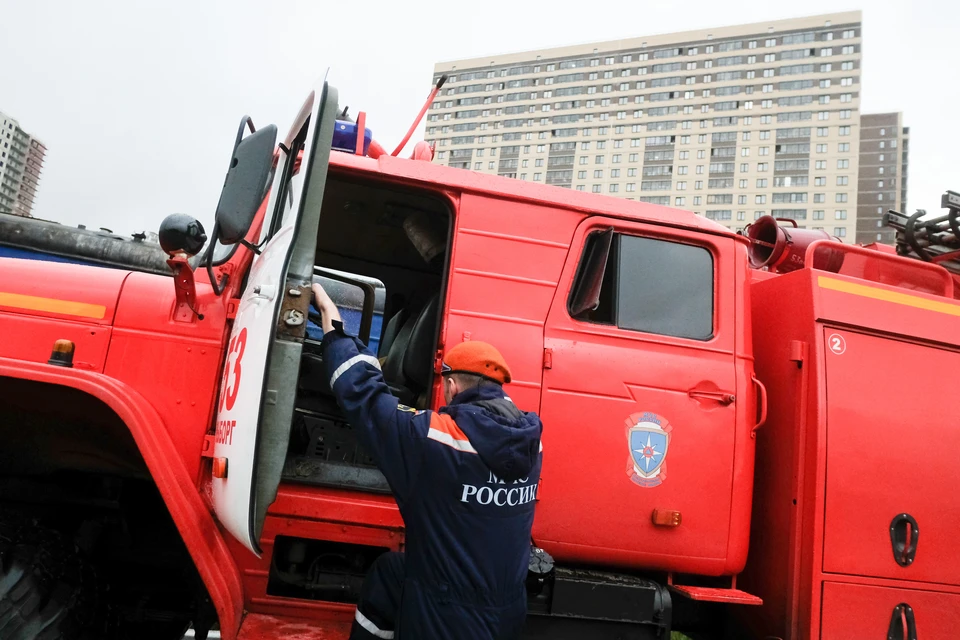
0,513,103,640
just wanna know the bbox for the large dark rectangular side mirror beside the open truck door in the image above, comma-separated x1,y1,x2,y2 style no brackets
215,116,277,245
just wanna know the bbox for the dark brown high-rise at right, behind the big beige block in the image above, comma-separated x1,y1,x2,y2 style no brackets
857,113,911,244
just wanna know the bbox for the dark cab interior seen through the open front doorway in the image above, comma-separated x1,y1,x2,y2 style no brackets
282,173,453,493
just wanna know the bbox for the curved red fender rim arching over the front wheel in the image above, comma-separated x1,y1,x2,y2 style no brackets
0,358,243,640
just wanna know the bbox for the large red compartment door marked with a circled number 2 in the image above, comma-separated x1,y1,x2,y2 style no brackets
823,327,960,584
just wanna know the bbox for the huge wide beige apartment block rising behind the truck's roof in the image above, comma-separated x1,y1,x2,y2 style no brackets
426,11,861,241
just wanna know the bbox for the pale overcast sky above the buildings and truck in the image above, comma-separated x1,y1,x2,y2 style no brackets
0,0,960,238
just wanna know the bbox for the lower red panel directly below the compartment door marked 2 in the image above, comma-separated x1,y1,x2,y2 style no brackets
820,582,960,640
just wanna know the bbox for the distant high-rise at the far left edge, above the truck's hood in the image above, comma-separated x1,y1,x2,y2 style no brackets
0,112,47,216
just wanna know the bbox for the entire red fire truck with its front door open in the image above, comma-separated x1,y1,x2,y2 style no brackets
0,77,960,640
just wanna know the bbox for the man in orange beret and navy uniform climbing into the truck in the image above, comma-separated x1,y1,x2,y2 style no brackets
313,284,543,640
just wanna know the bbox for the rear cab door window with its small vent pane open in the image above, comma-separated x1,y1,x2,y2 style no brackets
568,229,714,340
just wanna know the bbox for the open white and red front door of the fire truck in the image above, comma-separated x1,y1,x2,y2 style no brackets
212,82,337,555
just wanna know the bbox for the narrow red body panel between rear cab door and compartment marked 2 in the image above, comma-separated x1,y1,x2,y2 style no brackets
733,271,820,640
